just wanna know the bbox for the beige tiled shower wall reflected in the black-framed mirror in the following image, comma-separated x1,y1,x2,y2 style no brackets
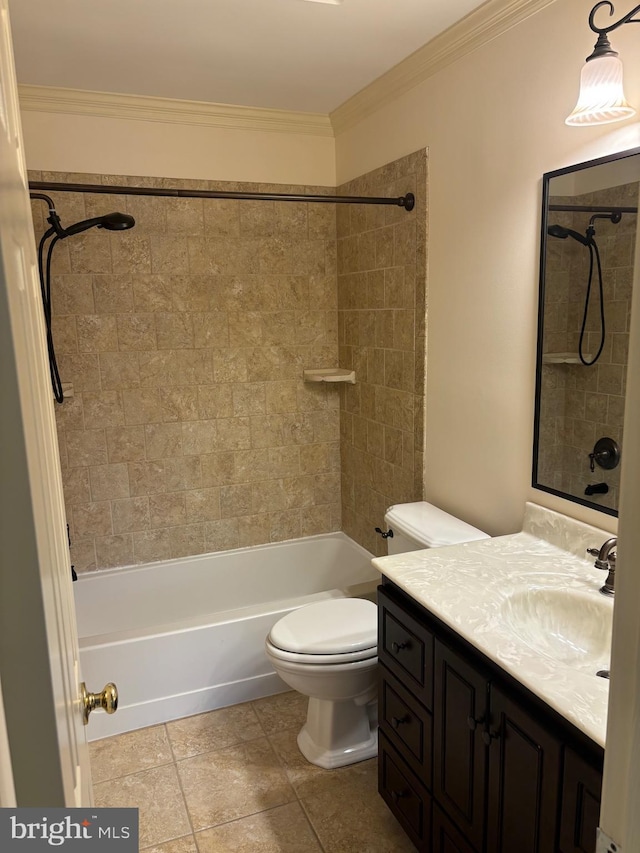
538,183,638,508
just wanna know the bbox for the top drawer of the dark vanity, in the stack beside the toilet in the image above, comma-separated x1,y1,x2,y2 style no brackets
378,587,433,710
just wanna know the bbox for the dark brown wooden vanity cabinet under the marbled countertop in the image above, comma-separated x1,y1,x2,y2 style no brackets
378,581,602,853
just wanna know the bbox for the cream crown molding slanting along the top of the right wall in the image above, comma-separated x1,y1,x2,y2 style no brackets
330,0,555,135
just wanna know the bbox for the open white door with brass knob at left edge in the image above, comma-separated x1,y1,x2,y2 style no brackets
0,0,91,807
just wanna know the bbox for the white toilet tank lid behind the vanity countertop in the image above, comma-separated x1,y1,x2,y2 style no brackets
384,501,489,548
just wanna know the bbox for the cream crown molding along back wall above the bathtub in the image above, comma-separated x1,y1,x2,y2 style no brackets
18,85,333,137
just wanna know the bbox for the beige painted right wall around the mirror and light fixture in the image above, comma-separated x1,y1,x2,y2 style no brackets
336,0,640,534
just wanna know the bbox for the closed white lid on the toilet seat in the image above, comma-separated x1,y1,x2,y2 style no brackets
269,598,377,655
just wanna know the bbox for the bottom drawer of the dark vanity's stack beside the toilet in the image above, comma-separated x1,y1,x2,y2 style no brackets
378,732,431,850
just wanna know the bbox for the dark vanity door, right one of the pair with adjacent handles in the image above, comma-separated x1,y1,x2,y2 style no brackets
484,687,561,853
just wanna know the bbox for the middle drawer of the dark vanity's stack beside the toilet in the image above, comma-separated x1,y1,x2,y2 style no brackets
378,665,433,788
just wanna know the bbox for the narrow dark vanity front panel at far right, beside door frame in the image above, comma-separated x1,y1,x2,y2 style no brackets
560,749,602,853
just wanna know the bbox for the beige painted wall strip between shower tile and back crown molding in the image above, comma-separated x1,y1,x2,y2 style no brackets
21,110,336,186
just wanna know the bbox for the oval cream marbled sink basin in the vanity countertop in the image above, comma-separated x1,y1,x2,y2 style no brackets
502,587,613,675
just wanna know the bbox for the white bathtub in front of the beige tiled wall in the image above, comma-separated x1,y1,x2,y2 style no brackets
73,533,379,740
